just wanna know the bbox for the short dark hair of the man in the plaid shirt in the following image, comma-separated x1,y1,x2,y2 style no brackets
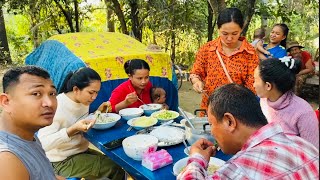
209,83,268,127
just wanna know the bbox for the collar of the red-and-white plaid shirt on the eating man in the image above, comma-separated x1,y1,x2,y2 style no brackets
240,122,283,152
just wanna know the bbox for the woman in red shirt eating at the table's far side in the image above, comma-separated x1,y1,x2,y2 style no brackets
109,59,152,113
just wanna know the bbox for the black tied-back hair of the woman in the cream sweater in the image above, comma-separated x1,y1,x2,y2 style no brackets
59,67,101,93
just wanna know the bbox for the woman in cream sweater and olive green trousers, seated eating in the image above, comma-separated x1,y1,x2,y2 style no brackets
38,67,124,180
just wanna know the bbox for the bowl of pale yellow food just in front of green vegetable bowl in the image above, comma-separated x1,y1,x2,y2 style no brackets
127,116,158,130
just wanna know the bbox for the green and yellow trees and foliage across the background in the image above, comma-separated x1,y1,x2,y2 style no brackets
0,0,319,68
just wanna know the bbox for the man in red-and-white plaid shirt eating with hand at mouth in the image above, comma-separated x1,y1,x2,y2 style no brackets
177,84,319,179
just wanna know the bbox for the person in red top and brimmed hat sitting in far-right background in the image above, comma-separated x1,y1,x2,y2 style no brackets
287,41,315,96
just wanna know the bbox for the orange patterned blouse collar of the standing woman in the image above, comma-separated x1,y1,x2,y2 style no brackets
209,37,256,54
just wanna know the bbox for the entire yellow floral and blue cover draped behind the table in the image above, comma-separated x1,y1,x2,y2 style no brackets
26,32,178,111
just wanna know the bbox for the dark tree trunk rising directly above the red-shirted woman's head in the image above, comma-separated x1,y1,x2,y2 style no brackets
130,0,142,42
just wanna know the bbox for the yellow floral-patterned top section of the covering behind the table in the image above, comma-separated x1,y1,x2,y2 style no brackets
49,32,172,81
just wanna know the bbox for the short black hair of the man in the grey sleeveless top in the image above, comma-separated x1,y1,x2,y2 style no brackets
2,66,50,92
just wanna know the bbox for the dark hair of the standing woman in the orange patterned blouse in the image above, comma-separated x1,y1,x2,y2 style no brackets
217,7,244,29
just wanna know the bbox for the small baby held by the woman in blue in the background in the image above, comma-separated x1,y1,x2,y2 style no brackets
251,28,272,60
